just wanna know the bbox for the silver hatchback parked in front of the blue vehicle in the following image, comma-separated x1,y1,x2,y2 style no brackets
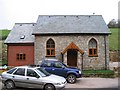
2,66,67,90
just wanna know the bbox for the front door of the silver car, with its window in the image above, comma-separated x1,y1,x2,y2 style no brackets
26,69,44,88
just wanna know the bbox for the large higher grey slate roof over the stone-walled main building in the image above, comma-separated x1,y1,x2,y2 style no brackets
33,15,110,35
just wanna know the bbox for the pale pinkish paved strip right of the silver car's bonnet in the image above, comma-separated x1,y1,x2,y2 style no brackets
66,78,120,88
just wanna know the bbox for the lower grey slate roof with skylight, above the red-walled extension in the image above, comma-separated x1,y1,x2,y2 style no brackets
4,23,36,44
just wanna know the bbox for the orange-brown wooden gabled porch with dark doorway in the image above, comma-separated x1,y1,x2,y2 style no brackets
61,42,84,68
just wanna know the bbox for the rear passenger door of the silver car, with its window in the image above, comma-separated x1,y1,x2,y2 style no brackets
12,68,26,87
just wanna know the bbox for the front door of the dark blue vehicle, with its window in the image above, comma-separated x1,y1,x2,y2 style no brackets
52,62,67,77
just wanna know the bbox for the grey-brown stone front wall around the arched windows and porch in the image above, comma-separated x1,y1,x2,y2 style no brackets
35,35,109,69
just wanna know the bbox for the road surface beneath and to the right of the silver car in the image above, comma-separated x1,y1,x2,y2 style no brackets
0,78,120,90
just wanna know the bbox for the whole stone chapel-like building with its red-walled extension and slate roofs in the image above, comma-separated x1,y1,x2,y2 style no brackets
5,15,110,69
